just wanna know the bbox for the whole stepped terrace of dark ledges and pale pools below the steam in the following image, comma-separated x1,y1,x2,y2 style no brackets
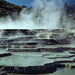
0,30,75,74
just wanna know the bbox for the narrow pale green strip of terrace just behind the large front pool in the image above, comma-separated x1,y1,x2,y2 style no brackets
11,52,73,58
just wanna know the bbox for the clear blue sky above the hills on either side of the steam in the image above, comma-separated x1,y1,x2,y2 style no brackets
6,0,75,8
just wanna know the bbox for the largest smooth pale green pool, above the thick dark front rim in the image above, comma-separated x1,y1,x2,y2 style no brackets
0,55,55,67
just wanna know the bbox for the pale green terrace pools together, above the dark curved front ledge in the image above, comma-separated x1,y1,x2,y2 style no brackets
0,50,75,67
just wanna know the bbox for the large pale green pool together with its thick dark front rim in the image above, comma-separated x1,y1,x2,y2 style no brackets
0,55,57,74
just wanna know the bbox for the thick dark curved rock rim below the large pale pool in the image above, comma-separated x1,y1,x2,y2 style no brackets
0,64,57,74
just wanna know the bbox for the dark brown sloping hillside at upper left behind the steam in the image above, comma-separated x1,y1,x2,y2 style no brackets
0,0,26,17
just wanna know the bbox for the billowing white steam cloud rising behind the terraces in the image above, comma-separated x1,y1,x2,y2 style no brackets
0,0,66,29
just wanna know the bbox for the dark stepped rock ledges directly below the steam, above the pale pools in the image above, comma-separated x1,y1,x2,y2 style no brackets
0,30,75,52
